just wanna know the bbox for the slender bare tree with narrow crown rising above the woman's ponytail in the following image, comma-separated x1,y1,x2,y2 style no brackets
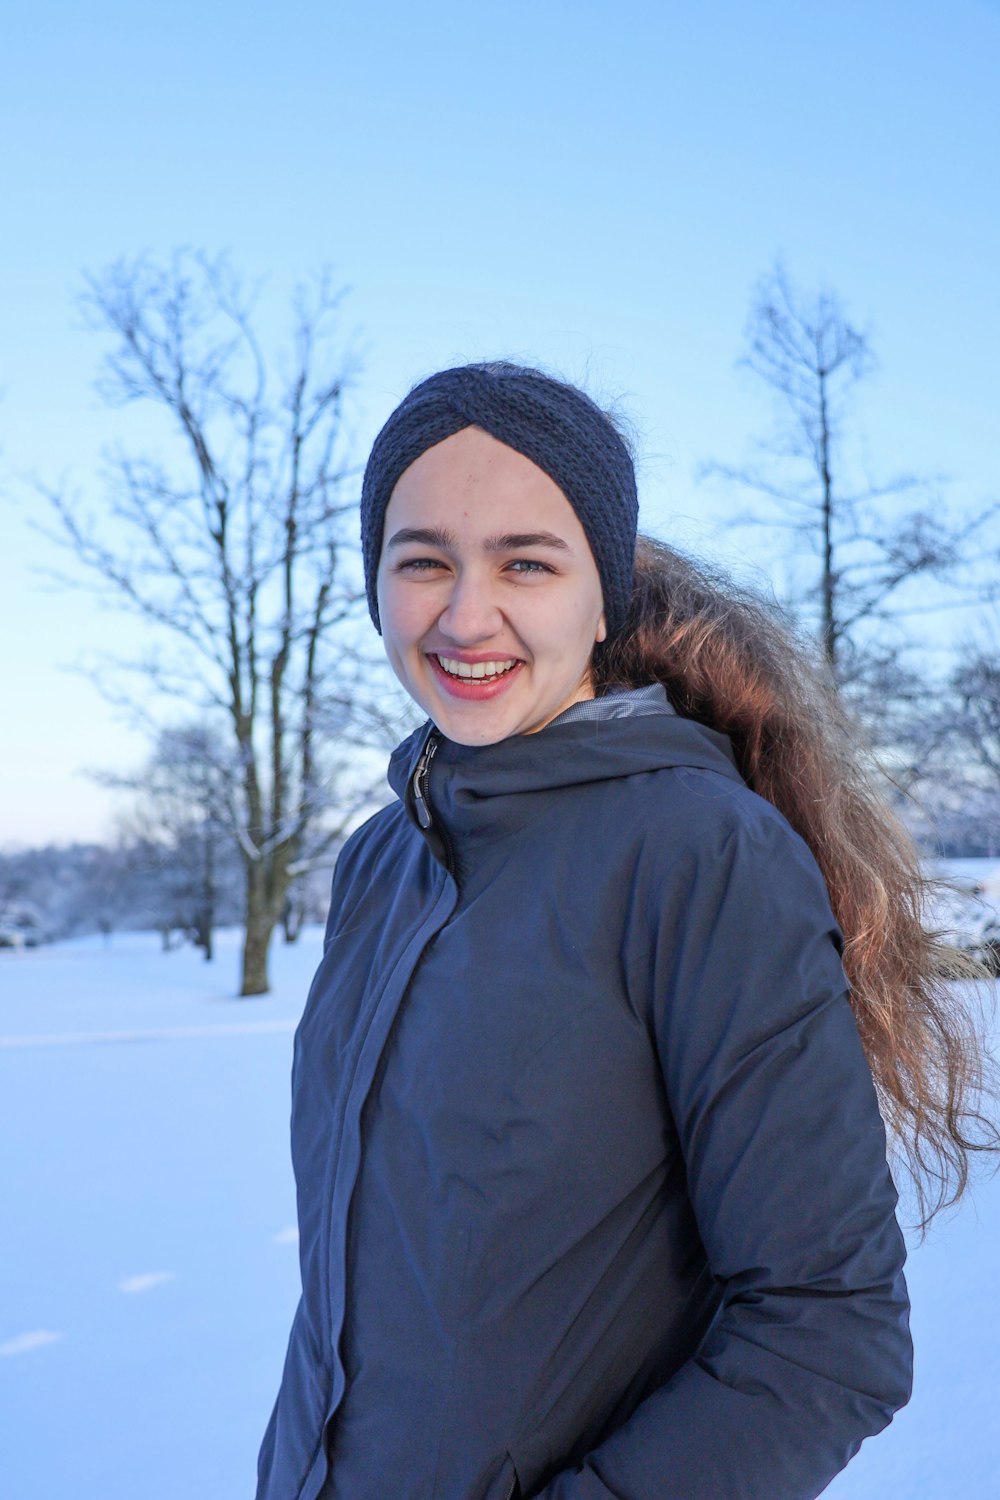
702,264,997,698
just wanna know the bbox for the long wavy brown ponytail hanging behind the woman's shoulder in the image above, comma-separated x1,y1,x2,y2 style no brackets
594,536,1000,1229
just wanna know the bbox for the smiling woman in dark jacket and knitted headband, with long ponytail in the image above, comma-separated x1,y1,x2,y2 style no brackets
258,363,1000,1500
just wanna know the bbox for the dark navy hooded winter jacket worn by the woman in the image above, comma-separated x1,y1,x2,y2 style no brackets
258,696,912,1500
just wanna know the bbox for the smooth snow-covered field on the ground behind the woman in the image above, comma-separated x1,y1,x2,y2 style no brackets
0,929,1000,1500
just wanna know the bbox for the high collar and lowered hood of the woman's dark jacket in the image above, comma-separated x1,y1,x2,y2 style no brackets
388,713,742,852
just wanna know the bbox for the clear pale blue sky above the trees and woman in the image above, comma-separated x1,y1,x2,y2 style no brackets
0,0,1000,846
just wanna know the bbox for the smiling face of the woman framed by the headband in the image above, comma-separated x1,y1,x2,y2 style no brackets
378,428,607,746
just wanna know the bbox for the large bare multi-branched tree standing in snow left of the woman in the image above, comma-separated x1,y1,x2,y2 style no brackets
38,252,374,995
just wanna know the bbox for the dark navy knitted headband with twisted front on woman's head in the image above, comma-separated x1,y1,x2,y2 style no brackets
361,369,639,639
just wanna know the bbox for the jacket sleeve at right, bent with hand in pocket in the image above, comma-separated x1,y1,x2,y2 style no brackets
538,798,912,1500
